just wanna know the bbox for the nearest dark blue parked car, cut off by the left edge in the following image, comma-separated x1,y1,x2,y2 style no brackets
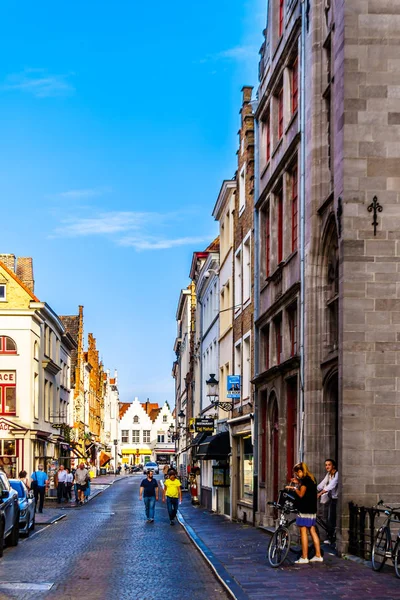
0,472,19,556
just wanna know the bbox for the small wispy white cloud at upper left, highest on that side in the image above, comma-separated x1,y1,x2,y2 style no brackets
0,69,75,98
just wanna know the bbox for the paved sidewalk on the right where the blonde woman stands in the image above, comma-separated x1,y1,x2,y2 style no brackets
179,495,400,600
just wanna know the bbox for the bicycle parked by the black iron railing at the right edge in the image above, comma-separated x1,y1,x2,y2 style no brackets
372,500,400,579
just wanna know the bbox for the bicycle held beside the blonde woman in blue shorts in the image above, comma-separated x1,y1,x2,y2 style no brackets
267,490,335,568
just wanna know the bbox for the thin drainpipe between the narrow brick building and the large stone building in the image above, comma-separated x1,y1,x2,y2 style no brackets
252,99,260,526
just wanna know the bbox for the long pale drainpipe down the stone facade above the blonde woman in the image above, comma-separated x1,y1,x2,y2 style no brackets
299,0,306,461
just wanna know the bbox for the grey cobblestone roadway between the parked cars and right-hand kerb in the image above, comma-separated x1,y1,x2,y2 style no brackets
0,476,228,600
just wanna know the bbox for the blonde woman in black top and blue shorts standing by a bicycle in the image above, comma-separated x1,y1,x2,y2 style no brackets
286,462,324,565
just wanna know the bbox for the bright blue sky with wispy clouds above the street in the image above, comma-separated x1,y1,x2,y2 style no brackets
0,0,266,403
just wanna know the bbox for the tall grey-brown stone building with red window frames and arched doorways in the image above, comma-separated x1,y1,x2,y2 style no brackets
255,0,400,549
